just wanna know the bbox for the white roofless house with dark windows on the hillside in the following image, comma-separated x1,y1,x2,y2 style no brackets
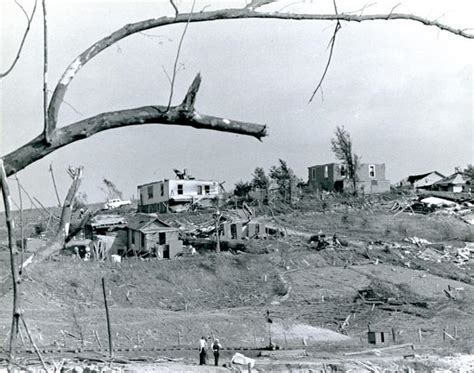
138,170,220,213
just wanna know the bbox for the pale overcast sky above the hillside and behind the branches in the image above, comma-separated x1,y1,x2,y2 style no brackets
0,0,474,205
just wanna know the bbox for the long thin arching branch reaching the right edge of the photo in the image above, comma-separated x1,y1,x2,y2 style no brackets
48,8,474,129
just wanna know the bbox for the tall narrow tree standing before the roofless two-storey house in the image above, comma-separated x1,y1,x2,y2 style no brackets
331,126,360,195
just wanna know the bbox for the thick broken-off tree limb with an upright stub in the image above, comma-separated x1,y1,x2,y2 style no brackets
3,74,267,176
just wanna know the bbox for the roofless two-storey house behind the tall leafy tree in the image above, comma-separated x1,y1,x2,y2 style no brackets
308,163,390,194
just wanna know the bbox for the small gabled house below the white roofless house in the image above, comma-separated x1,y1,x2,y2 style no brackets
125,214,183,259
